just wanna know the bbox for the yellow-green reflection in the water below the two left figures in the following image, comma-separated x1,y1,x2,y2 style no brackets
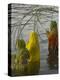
11,62,40,76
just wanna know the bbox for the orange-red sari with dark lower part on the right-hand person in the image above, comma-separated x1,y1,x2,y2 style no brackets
48,31,58,66
